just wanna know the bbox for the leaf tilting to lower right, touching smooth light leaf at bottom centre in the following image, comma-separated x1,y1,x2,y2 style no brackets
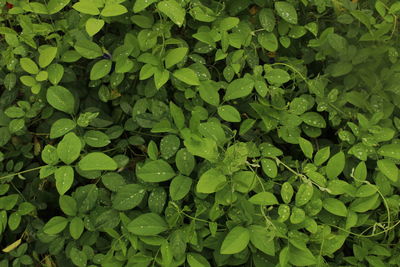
248,225,275,256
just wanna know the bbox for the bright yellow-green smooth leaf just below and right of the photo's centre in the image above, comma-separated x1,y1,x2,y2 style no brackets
196,168,226,194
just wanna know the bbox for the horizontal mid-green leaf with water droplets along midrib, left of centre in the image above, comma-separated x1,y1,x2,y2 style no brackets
136,159,175,183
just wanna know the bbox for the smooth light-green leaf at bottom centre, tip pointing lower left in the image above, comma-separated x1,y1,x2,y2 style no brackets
220,226,250,254
